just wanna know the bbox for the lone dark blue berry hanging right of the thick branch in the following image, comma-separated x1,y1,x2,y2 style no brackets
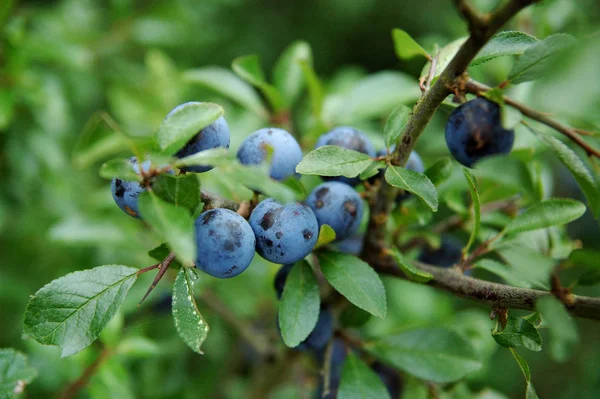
446,97,515,167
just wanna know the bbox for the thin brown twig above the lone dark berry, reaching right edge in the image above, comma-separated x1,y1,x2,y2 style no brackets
465,79,600,158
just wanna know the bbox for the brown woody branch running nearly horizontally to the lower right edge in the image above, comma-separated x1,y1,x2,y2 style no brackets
363,256,600,320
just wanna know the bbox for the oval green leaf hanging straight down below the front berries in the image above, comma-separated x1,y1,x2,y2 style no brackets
278,261,321,348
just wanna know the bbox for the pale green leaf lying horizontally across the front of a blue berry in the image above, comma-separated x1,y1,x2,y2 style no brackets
296,145,373,177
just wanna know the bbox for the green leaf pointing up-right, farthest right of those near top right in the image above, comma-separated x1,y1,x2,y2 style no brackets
508,33,576,84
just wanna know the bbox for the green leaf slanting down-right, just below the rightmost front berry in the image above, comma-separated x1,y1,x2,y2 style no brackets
318,252,387,318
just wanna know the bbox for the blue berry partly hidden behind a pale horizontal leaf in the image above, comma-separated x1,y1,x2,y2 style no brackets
315,126,375,186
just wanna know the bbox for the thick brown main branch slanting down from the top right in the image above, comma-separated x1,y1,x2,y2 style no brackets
363,0,535,260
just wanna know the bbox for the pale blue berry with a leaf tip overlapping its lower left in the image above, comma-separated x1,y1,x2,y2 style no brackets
237,128,302,180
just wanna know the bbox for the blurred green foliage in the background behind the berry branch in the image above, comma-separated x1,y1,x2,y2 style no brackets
0,0,600,398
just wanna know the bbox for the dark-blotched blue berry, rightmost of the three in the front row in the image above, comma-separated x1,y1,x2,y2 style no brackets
306,181,363,240
